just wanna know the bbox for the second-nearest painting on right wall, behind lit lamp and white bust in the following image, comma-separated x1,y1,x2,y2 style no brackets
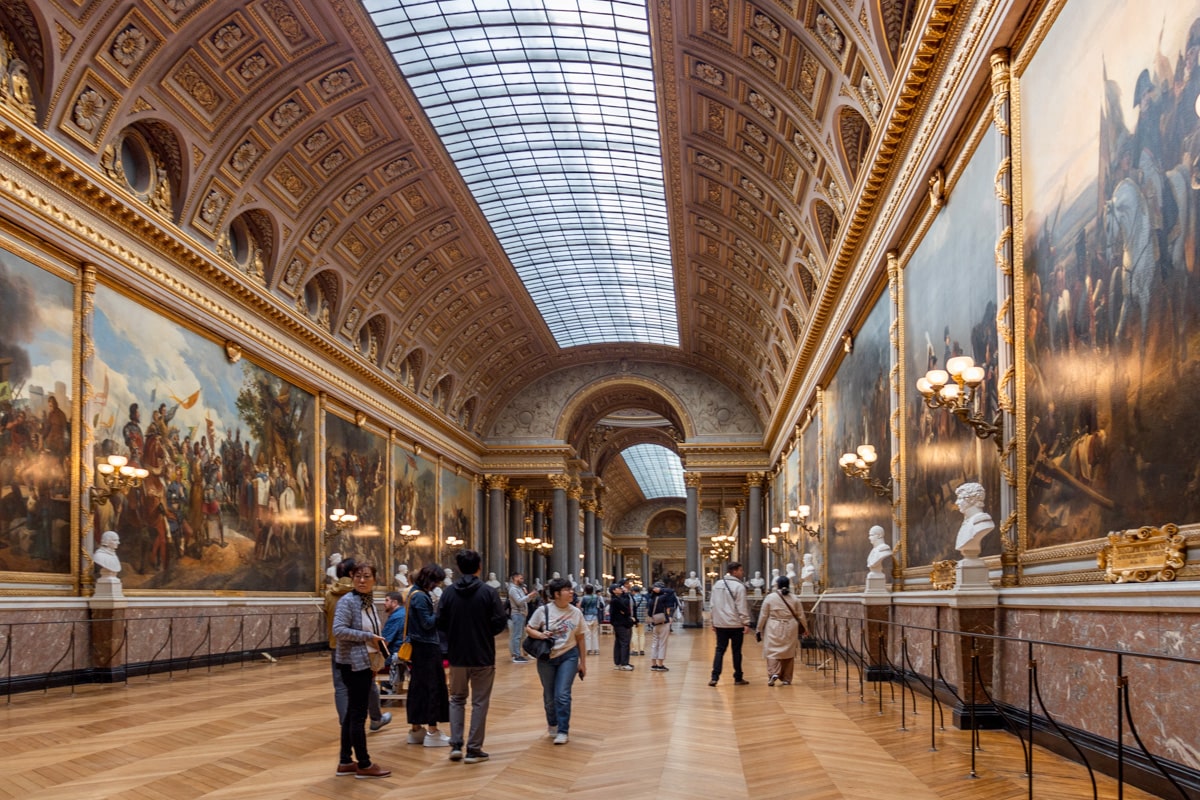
901,128,1001,566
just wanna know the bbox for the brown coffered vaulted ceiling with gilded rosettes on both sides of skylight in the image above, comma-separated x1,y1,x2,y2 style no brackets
0,0,917,444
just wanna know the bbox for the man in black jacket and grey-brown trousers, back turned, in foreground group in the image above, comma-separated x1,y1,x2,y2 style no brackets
437,551,509,764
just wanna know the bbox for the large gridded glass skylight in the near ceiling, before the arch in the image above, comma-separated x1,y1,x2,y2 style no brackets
364,0,679,347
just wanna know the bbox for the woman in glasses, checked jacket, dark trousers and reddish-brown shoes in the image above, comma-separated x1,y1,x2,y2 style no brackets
334,561,391,778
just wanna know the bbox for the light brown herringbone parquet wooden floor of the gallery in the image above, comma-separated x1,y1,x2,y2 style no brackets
0,630,1166,800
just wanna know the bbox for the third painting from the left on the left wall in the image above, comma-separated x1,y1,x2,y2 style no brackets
324,414,390,575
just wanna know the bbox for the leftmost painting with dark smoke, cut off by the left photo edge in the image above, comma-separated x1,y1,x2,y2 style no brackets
0,249,74,573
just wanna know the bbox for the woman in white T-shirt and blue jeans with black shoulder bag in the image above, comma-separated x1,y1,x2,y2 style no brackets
526,578,588,745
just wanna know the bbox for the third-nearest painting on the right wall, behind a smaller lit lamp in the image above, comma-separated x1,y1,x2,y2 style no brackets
822,293,892,588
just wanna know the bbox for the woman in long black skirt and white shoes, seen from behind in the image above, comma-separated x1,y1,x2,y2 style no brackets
406,564,450,747
